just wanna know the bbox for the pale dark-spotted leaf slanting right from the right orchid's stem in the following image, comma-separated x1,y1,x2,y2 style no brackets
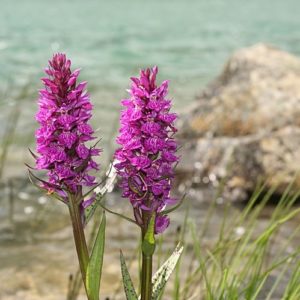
151,244,183,300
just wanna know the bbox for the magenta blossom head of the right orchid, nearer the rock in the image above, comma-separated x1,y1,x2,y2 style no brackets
115,67,178,233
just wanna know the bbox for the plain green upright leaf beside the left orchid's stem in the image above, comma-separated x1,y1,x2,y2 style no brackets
86,212,106,300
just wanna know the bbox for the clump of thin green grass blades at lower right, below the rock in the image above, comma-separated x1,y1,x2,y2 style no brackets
127,182,300,300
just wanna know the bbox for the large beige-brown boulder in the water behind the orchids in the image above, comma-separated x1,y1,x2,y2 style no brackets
178,44,300,198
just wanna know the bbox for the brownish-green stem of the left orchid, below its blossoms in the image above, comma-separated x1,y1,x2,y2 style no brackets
69,195,89,294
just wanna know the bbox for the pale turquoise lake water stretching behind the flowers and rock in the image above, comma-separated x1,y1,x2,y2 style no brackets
0,0,300,155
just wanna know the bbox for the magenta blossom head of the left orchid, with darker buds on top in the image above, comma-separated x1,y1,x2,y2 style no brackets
35,53,100,200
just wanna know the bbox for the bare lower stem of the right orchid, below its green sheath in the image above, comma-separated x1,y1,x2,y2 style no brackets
141,253,152,300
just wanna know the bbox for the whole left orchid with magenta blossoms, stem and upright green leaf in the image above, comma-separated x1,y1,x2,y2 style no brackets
30,53,105,300
